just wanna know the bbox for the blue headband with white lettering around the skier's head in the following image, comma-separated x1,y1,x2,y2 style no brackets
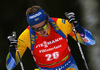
27,8,47,26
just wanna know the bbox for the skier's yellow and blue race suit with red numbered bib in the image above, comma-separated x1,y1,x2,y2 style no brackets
6,18,95,70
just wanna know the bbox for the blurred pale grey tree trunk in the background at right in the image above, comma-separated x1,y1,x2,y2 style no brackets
79,0,100,70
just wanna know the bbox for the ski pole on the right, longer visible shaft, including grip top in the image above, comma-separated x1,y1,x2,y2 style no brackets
65,12,89,70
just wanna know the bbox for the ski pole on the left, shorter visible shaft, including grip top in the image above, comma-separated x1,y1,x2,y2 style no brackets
8,31,24,70
